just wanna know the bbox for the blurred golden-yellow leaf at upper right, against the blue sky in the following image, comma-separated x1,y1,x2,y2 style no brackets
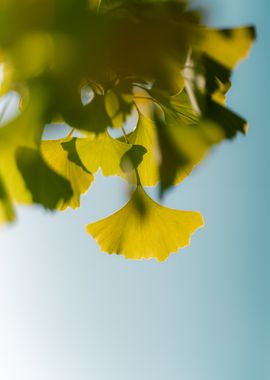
199,27,255,69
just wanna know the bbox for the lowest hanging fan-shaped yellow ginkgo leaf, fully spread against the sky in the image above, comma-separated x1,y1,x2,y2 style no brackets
86,187,204,261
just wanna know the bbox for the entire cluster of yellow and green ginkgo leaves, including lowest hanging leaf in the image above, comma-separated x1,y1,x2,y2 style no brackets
0,0,255,261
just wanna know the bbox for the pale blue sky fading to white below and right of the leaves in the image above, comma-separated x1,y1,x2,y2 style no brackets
0,0,270,380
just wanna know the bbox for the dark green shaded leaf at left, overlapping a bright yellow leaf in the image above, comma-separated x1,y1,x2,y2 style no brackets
16,147,73,210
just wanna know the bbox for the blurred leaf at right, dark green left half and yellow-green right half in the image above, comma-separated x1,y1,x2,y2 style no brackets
156,104,225,195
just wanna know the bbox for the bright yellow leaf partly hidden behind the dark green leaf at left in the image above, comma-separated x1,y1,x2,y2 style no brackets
40,138,94,210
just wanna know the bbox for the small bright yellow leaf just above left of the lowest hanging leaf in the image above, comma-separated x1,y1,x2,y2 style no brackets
76,132,131,176
